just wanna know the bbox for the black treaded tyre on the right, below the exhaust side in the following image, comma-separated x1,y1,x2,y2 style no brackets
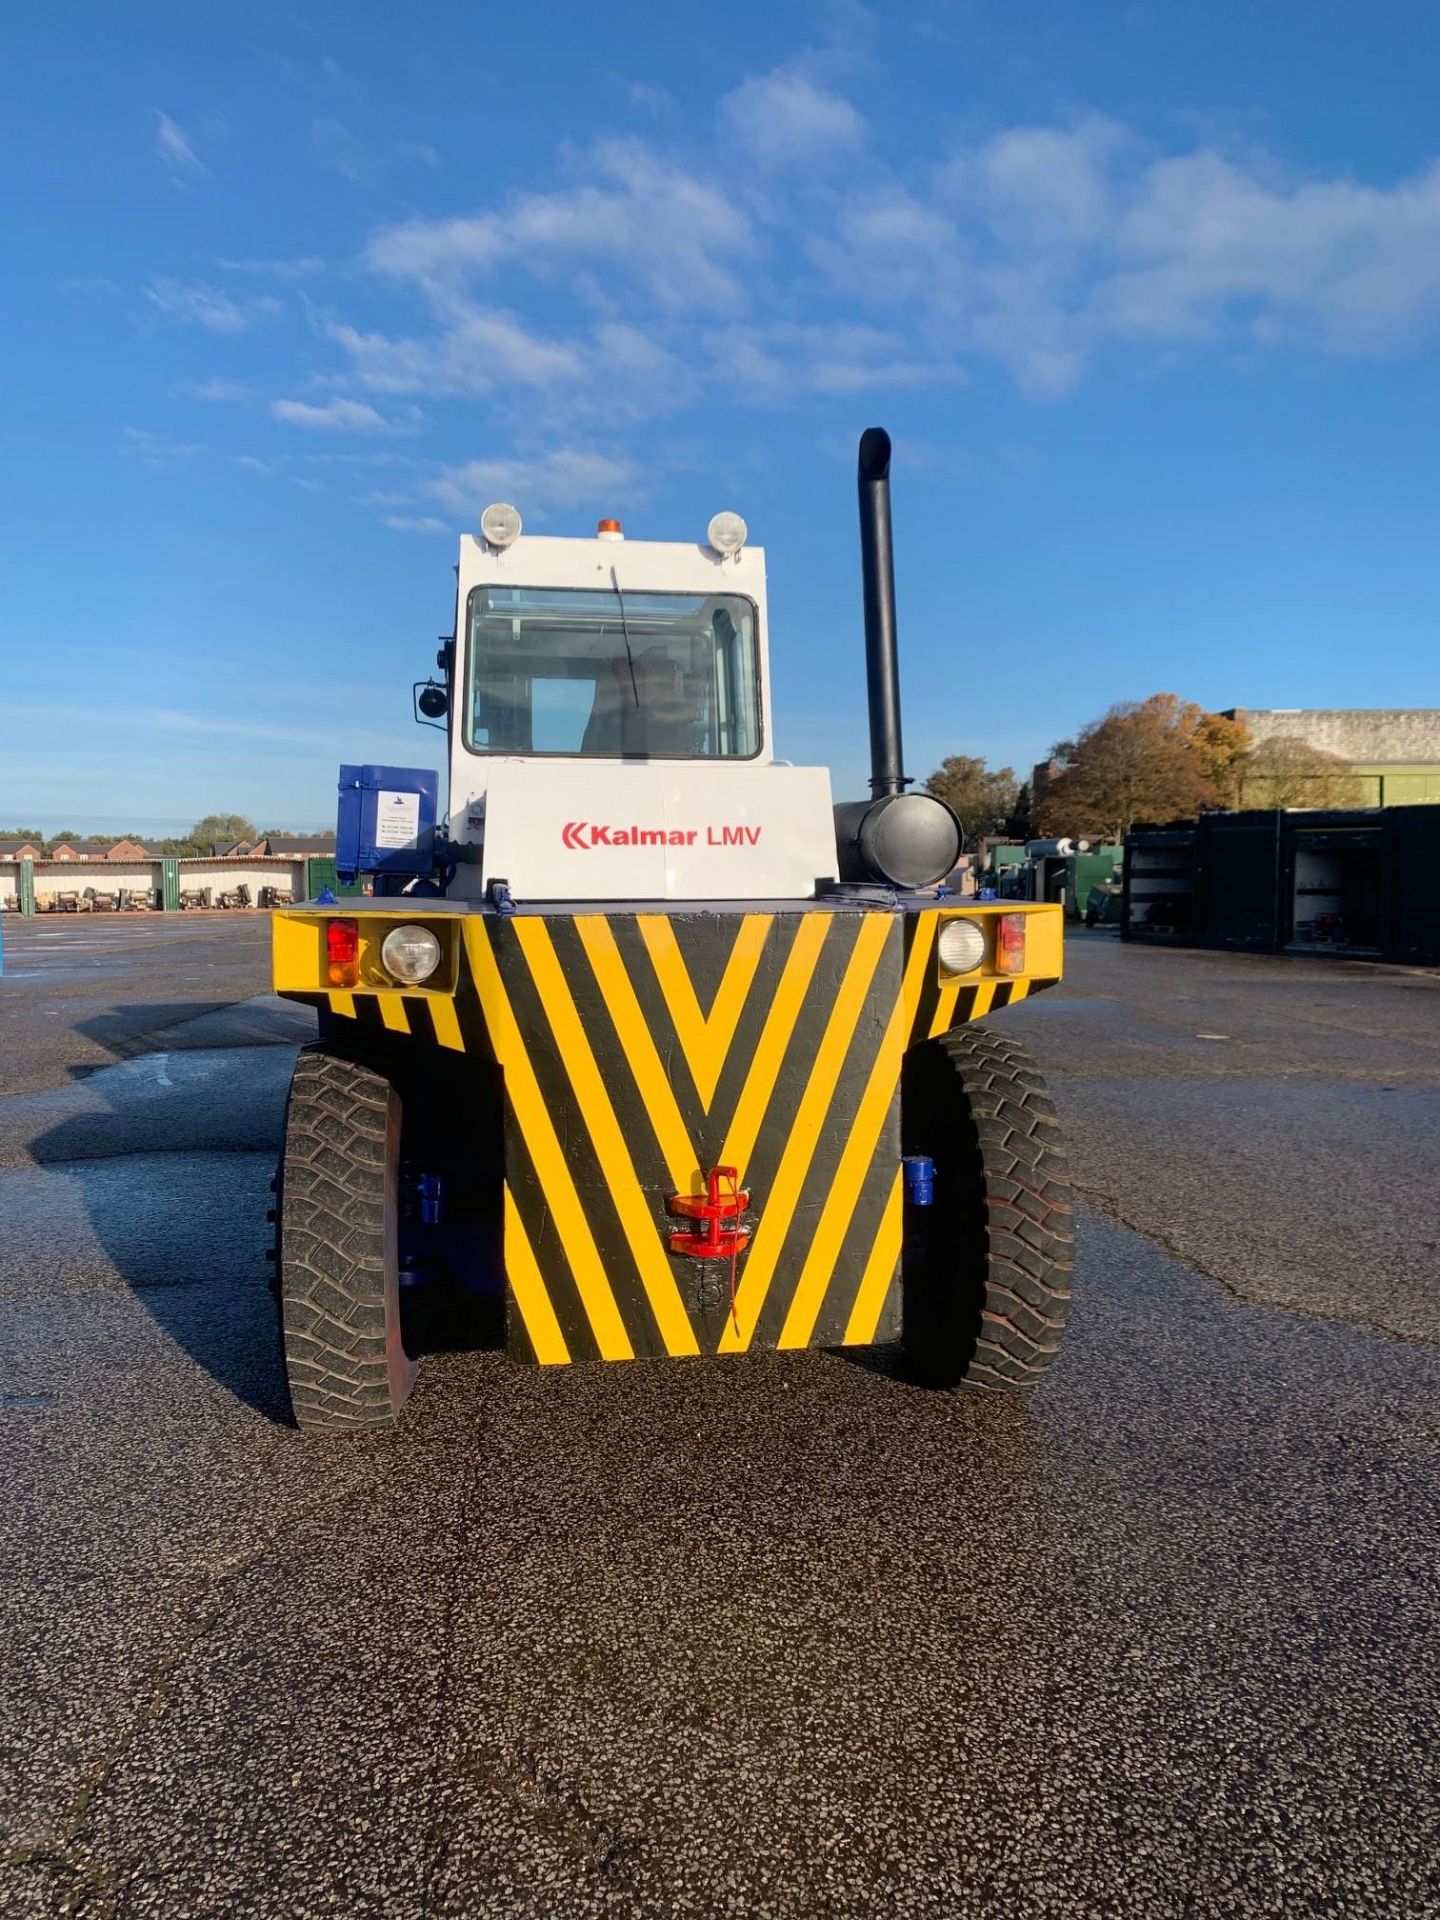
900,1027,1075,1392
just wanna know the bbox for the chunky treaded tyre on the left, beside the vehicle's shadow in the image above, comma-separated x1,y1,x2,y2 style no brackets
276,1046,415,1432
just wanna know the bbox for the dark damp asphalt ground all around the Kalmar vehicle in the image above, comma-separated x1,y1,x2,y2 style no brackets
0,916,1440,1920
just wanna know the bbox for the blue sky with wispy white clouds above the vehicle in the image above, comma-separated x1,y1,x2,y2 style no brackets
0,0,1440,829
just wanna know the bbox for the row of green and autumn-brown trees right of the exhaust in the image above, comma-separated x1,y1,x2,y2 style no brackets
925,693,1365,843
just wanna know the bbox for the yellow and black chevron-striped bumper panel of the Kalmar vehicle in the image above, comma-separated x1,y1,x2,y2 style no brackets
275,900,1060,1363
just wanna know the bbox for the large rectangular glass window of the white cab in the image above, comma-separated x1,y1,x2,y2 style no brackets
465,586,760,760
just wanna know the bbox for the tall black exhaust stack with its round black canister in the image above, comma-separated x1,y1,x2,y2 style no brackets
835,426,964,889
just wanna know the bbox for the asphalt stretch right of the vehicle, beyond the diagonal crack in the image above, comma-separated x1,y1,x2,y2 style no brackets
996,931,1440,1344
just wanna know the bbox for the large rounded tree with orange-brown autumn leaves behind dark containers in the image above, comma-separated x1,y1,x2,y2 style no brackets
1035,693,1227,843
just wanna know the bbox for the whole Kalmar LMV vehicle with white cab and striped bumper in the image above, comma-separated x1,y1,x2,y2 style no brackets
275,428,1073,1432
